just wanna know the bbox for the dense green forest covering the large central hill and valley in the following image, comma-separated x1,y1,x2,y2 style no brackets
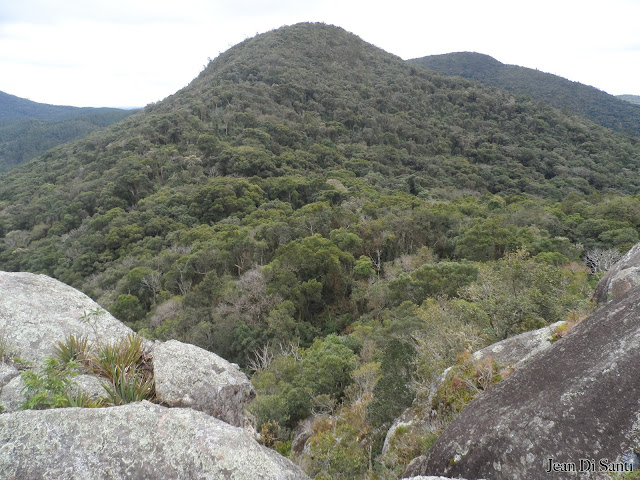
0,24,640,479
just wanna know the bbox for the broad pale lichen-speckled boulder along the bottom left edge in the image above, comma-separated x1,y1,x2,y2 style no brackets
0,402,308,480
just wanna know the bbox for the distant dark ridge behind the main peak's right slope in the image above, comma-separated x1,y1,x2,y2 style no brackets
409,52,640,136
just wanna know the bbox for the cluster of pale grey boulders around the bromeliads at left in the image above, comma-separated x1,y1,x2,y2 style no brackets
0,272,308,479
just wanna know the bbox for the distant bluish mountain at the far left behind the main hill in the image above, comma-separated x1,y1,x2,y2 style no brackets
0,92,132,172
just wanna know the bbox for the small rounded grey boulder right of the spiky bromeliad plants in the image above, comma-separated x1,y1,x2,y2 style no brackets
152,340,255,426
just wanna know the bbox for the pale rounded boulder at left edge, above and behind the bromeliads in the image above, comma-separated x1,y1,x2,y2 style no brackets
0,272,133,363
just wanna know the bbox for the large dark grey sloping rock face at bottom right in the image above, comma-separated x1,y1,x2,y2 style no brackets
405,288,640,480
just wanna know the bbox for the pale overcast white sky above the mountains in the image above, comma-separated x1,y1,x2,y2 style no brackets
0,0,640,107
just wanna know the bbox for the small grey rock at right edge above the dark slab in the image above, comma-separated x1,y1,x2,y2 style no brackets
593,243,640,304
